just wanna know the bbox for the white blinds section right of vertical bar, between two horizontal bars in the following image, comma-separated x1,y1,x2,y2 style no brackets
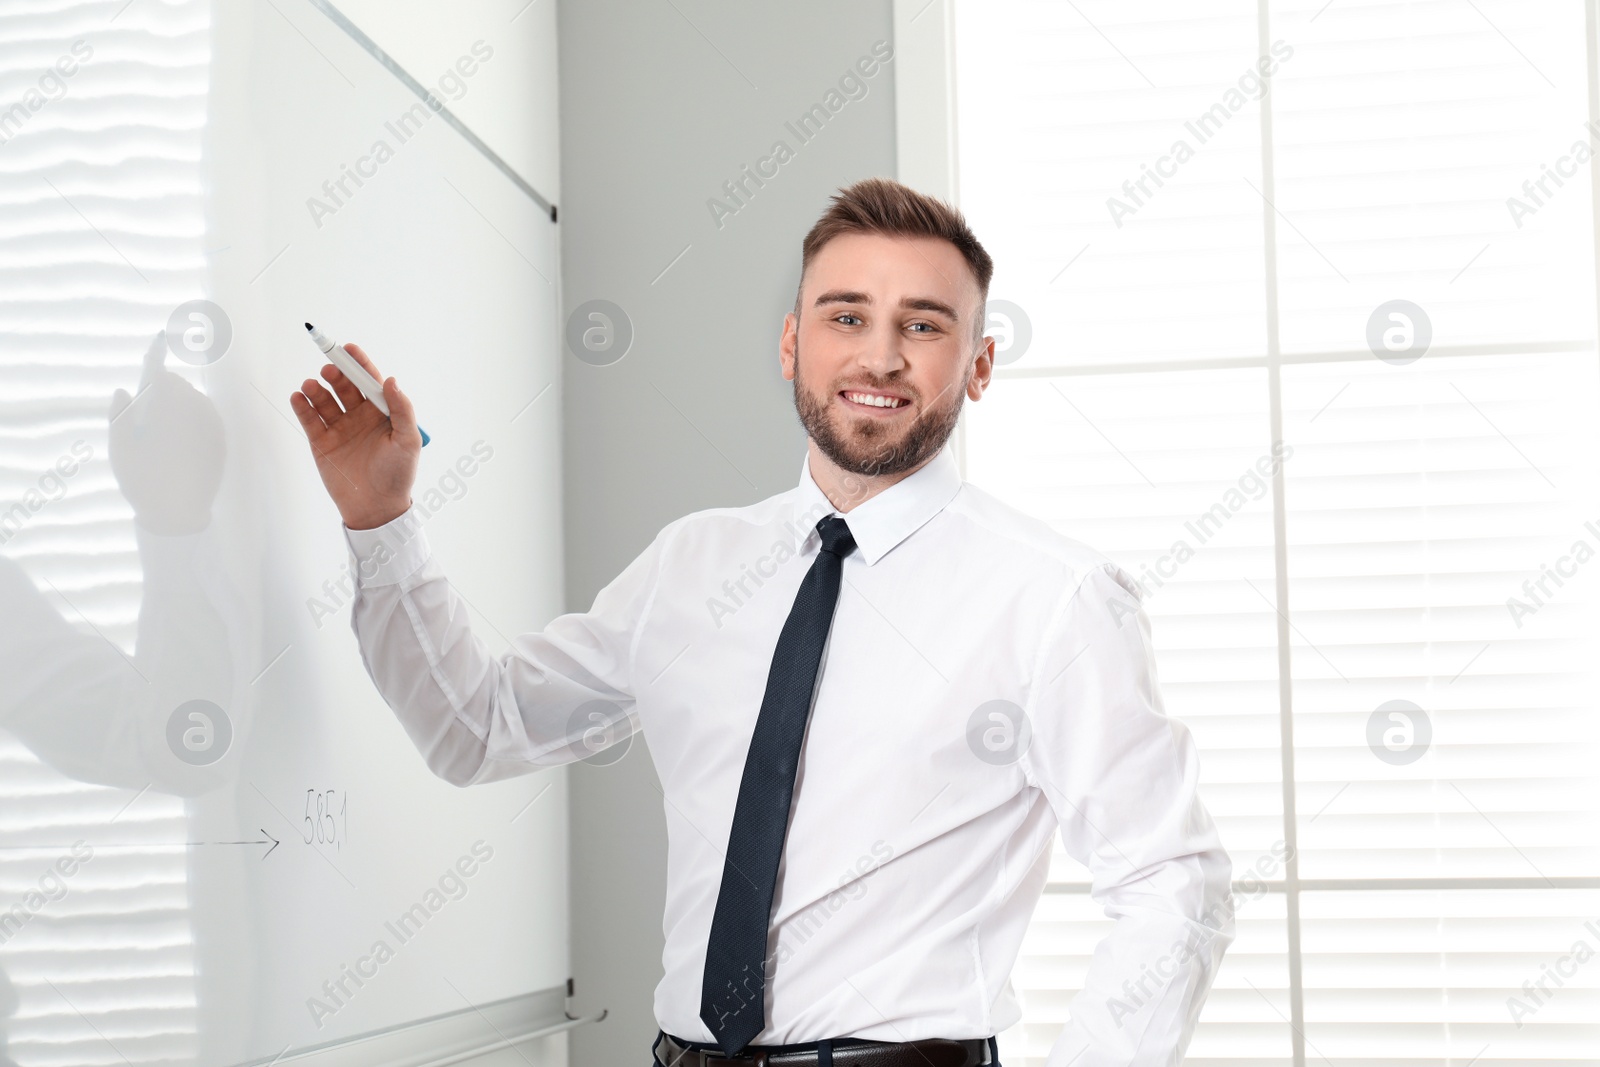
1283,350,1600,883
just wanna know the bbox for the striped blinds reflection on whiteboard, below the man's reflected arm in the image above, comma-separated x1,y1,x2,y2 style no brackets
0,734,197,1067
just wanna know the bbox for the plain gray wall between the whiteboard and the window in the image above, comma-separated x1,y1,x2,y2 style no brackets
558,0,894,1067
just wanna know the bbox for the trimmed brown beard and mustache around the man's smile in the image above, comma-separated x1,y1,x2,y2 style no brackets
795,338,973,477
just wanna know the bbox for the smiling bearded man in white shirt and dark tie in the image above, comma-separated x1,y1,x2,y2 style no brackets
291,179,1234,1067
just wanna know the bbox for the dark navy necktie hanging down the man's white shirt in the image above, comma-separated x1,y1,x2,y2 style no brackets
701,515,856,1056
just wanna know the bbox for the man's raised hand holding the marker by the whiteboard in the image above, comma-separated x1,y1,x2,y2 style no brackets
290,344,422,530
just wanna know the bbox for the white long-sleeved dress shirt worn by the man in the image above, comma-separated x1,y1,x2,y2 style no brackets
346,450,1234,1067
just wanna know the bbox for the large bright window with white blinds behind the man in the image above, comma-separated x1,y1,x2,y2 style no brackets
947,0,1600,1067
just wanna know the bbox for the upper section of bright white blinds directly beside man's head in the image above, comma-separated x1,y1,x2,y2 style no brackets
955,0,1266,368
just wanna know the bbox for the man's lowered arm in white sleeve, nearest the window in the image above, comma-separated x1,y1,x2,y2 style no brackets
1022,565,1234,1067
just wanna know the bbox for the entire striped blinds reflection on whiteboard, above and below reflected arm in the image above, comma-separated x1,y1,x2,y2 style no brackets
0,0,210,1067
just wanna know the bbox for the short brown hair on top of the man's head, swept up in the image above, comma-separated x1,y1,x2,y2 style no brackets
795,178,995,338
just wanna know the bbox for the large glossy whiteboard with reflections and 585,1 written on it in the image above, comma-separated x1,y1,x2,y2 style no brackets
0,0,570,1067
